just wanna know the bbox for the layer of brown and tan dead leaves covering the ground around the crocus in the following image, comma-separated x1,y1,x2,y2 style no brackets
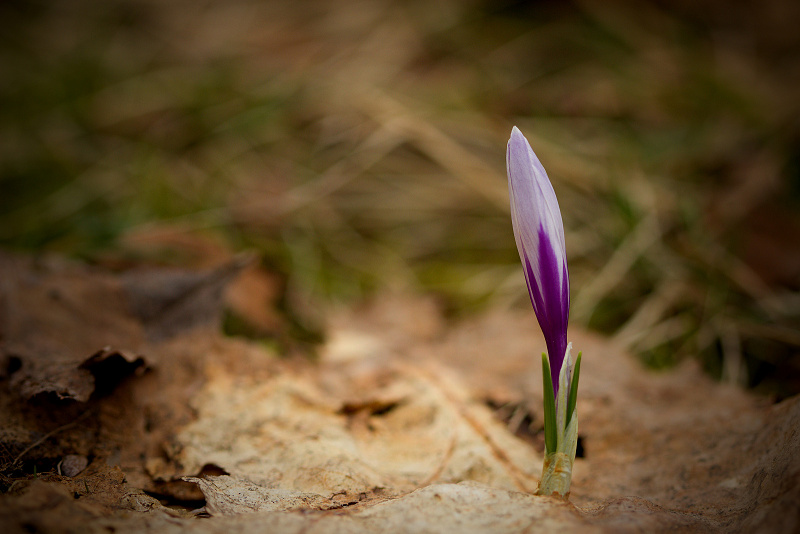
0,255,800,533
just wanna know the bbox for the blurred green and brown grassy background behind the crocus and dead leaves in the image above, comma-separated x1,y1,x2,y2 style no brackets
0,0,800,399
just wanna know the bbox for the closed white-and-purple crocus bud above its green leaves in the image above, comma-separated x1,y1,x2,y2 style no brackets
506,126,569,397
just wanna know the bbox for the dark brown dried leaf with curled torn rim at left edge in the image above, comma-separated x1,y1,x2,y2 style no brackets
0,254,148,401
